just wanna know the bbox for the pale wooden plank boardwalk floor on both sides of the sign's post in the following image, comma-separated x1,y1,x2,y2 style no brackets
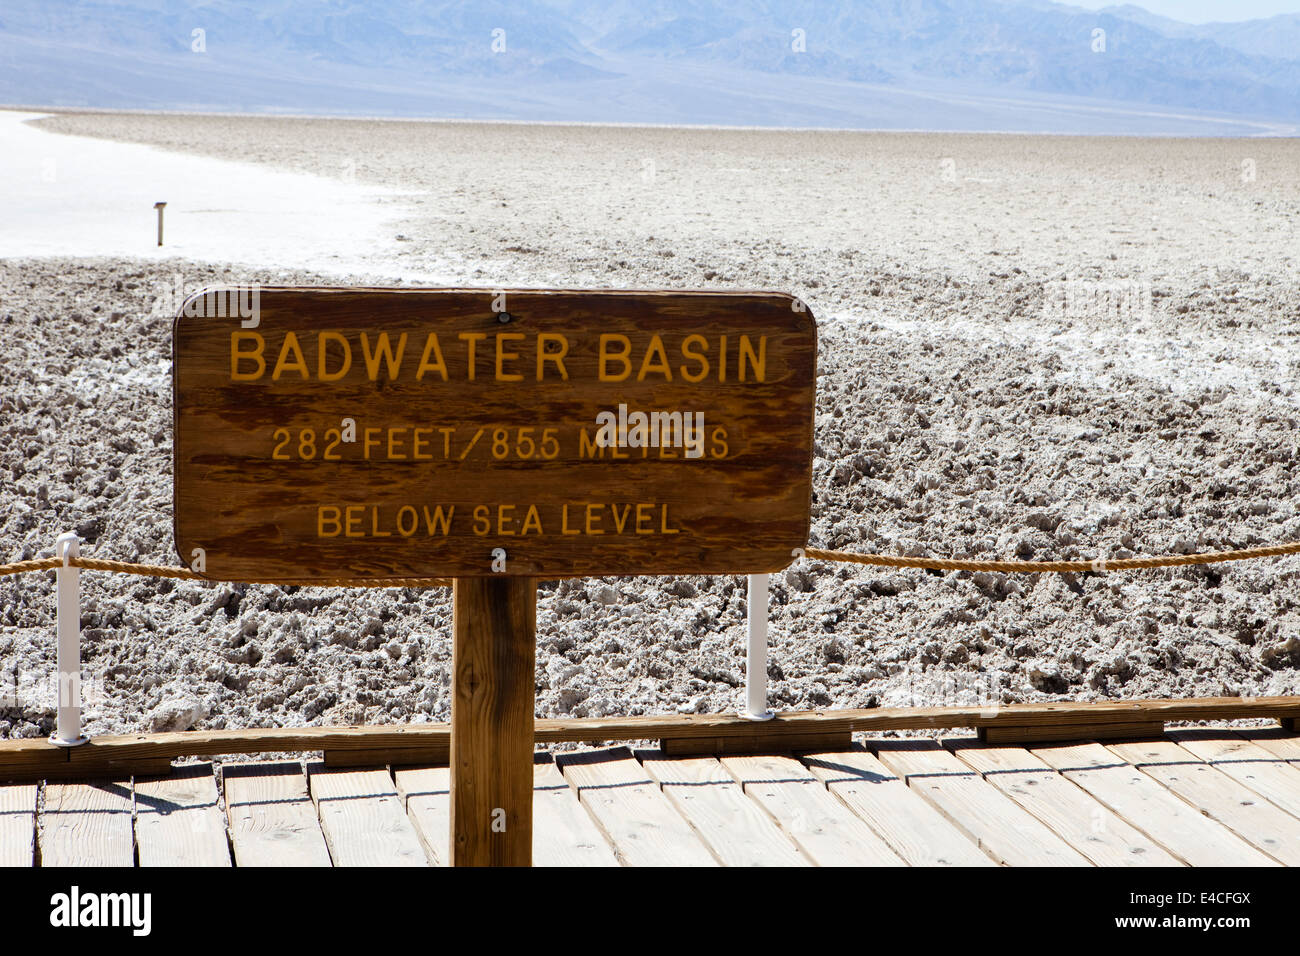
0,728,1300,866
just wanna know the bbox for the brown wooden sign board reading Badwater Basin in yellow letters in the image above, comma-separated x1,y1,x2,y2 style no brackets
173,289,816,583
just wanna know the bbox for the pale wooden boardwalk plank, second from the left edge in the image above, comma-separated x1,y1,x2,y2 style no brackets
39,783,135,866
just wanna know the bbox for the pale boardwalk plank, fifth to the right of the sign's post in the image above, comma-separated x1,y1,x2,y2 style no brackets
802,745,993,866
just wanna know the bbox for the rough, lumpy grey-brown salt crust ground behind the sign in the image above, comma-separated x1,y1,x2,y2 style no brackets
0,117,1300,736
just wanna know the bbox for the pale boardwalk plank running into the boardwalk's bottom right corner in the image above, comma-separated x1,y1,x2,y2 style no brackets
1109,740,1300,866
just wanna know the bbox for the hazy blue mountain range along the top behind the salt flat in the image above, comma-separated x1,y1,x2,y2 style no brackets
0,0,1300,134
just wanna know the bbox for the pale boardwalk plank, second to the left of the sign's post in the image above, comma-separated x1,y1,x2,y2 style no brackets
307,765,428,866
